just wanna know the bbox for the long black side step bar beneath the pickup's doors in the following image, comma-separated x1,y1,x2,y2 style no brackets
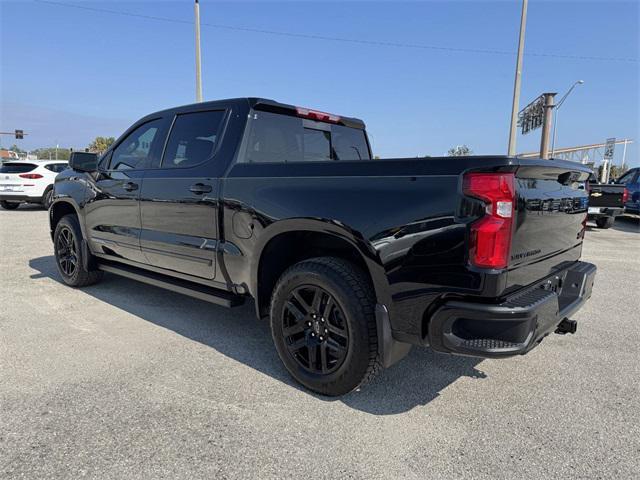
98,263,244,308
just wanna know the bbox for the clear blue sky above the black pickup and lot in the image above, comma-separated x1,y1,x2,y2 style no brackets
0,0,640,164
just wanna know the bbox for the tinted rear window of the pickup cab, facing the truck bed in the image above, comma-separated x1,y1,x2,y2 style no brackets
240,111,371,163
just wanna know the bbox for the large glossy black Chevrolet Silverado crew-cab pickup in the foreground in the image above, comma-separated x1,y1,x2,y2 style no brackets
50,98,596,395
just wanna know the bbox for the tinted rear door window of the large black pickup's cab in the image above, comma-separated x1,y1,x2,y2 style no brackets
161,110,225,168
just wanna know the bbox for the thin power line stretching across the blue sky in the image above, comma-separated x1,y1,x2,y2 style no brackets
34,0,638,63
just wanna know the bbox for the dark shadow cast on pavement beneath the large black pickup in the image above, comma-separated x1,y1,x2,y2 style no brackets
29,255,486,415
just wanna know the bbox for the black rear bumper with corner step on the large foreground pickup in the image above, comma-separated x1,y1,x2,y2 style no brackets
428,262,596,357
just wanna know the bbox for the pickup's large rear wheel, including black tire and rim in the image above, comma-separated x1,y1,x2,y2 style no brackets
270,257,380,396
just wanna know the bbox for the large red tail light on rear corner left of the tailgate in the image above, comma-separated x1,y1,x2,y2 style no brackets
463,173,515,268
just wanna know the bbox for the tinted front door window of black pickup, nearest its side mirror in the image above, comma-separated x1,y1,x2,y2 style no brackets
109,119,162,170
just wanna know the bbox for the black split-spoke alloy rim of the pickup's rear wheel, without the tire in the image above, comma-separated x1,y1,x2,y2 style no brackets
282,285,349,374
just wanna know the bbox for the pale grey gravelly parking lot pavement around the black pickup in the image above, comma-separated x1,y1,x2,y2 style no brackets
0,207,640,479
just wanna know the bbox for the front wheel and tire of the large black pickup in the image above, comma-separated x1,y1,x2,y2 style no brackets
53,214,104,287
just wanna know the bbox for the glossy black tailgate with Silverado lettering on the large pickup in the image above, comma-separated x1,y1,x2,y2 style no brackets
507,161,588,288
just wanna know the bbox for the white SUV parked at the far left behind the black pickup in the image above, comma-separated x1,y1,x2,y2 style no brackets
0,160,68,210
